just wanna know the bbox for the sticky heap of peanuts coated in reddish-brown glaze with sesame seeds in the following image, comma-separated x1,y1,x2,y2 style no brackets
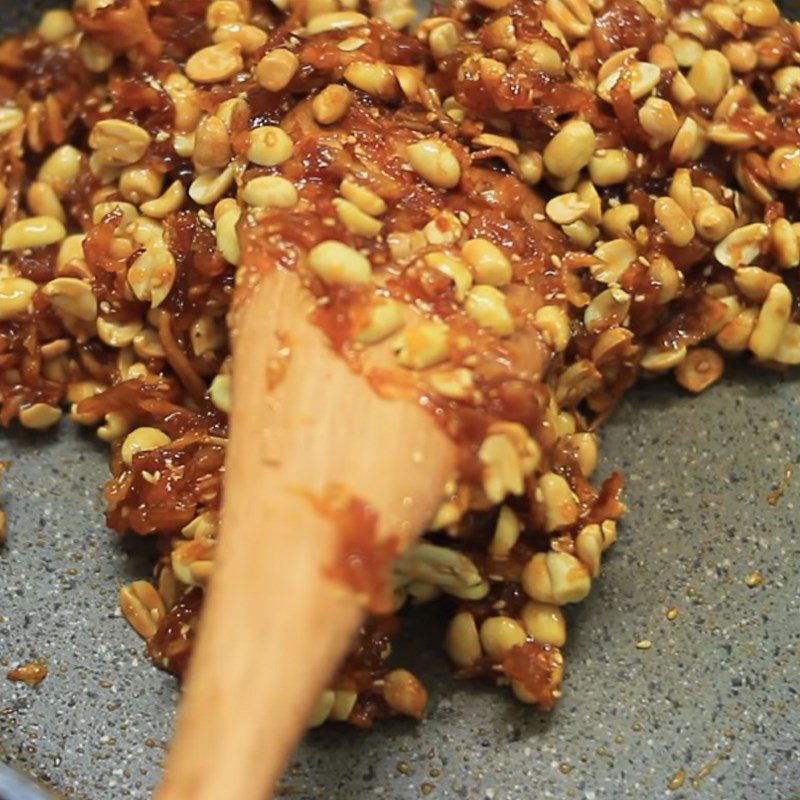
0,0,800,725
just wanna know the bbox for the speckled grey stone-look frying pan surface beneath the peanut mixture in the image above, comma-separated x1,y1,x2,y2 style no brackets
0,0,800,800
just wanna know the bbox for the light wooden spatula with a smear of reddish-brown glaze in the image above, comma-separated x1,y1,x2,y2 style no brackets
156,271,455,800
